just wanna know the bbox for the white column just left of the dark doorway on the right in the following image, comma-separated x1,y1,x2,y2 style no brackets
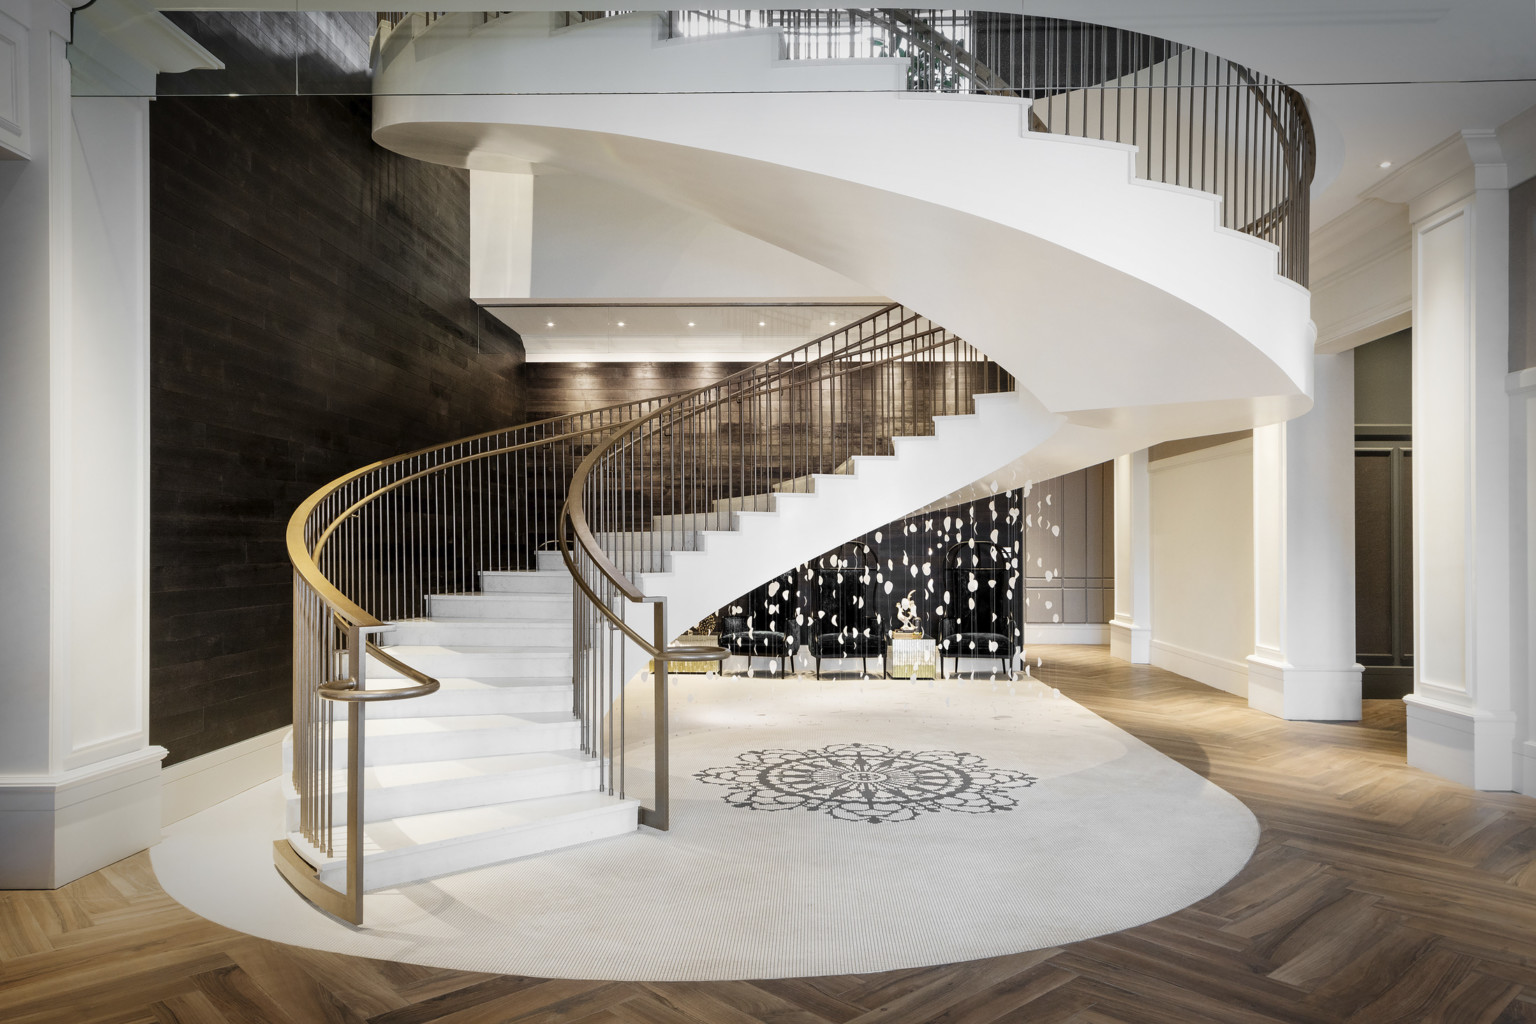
1247,352,1361,722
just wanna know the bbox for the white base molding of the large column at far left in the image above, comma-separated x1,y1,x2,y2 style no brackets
0,746,166,889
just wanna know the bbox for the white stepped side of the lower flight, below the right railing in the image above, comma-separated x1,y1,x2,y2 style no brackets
627,393,1061,647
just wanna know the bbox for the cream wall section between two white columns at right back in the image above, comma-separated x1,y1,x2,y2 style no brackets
1149,439,1253,695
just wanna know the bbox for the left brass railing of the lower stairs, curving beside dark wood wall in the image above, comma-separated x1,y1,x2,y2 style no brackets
273,306,919,923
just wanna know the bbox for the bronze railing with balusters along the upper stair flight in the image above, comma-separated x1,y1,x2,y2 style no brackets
663,8,1316,286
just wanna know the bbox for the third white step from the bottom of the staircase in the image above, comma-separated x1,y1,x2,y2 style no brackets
283,708,581,771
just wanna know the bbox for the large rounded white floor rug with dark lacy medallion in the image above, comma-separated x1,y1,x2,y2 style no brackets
152,676,1258,981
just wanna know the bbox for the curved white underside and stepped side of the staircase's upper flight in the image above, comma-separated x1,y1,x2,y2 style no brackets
375,17,1312,411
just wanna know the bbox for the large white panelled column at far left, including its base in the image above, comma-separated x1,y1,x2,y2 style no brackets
0,0,215,889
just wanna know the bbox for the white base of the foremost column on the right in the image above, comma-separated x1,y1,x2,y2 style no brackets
1402,694,1511,791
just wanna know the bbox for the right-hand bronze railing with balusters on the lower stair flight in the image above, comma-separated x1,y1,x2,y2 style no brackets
558,306,1014,829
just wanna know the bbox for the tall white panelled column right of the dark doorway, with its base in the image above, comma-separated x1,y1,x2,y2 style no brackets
1404,130,1516,789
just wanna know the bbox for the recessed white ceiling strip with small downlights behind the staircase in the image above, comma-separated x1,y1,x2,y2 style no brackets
487,302,882,362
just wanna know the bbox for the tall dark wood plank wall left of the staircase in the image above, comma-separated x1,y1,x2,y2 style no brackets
151,97,525,763
